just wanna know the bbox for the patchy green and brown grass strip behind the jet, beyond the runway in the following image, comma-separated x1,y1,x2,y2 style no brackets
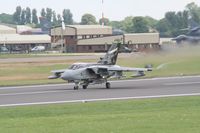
0,47,200,86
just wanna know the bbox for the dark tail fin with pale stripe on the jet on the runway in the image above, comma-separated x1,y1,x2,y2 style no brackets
98,43,131,65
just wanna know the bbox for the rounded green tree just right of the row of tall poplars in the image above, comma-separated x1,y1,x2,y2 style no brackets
81,14,97,25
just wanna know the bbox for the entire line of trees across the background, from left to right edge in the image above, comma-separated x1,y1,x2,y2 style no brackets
0,2,200,37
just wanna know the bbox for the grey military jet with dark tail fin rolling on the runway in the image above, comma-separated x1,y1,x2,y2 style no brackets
48,43,152,90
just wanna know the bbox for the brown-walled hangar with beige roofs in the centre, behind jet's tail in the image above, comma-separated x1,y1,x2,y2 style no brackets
50,25,160,52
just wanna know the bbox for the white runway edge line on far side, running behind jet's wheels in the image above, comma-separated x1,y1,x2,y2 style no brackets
0,75,200,90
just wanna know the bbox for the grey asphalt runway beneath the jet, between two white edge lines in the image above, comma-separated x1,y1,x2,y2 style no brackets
0,76,200,107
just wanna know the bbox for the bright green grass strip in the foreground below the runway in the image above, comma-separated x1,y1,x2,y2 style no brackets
0,96,200,133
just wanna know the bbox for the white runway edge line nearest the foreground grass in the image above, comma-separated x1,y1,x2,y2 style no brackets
0,93,200,107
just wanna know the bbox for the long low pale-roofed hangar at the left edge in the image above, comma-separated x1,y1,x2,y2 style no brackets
0,25,51,53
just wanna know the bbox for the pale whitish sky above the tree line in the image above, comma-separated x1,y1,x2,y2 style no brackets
0,0,200,22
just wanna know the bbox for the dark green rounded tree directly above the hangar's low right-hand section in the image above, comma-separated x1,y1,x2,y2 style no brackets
132,17,149,33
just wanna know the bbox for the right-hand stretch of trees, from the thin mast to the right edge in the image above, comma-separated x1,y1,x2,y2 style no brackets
110,2,200,37
